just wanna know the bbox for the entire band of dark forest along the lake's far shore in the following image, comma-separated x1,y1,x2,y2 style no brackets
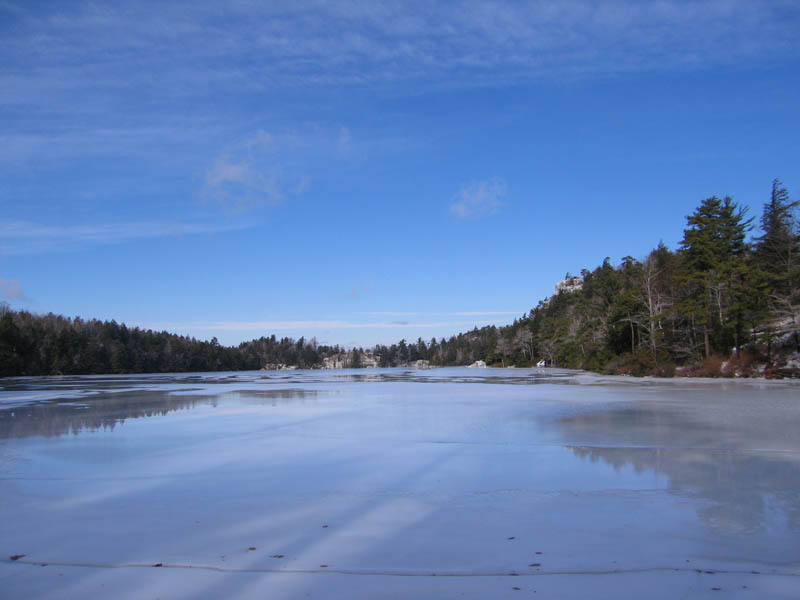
0,180,800,376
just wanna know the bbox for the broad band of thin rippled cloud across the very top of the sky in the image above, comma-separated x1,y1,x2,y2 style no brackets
0,0,800,114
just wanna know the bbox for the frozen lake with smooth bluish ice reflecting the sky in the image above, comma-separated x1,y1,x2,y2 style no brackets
0,369,800,599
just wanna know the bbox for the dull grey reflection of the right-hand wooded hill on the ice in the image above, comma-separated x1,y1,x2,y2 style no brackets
559,388,800,534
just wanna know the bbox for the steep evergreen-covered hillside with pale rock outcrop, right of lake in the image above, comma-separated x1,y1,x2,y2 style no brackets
436,180,800,375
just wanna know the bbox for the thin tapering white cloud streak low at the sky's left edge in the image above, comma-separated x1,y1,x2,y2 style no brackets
0,221,247,256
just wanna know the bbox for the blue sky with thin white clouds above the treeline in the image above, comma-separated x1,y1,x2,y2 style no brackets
0,0,800,345
